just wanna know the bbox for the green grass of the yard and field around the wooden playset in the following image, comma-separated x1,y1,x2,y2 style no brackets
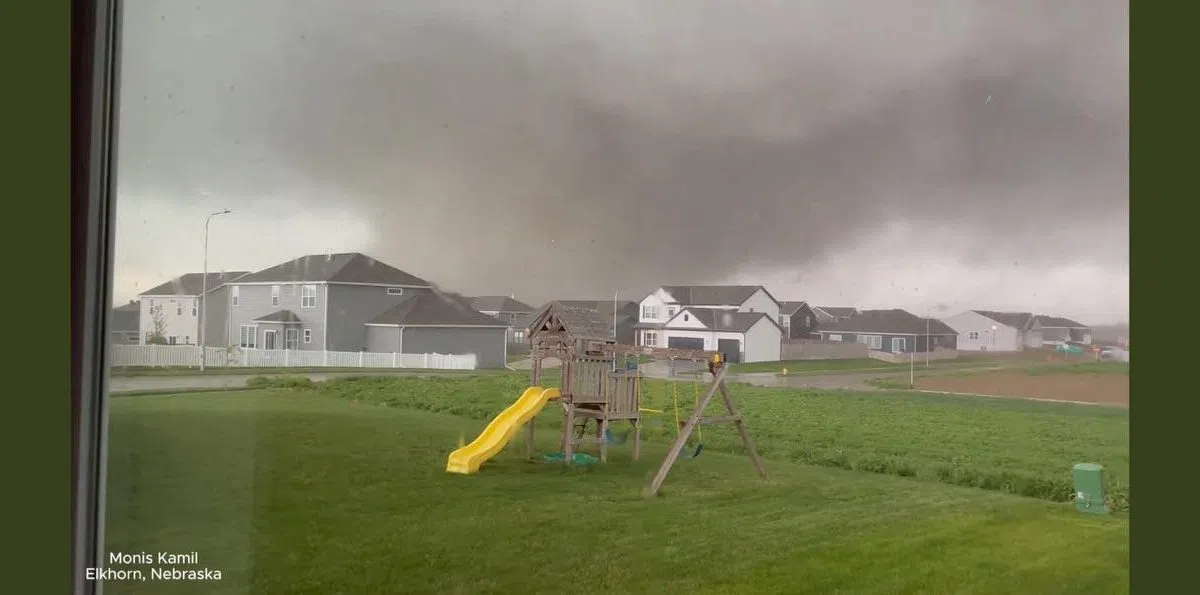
106,391,1129,594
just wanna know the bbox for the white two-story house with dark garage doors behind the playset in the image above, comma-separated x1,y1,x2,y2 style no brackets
636,286,784,362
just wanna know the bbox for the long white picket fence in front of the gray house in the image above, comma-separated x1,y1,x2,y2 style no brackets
108,345,475,369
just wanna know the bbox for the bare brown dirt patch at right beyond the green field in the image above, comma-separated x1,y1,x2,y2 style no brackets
917,372,1129,407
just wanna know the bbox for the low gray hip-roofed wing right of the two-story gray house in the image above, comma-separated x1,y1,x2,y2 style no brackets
366,290,511,368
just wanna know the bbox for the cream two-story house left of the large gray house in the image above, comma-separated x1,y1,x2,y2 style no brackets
138,271,247,345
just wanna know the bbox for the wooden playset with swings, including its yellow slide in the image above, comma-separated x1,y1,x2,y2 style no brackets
446,307,767,495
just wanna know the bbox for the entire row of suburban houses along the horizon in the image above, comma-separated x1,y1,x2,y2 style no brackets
110,248,1091,367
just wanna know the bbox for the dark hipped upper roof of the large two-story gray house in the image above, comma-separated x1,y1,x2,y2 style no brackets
231,252,433,287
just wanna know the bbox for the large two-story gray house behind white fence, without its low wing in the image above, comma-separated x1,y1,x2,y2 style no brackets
223,252,433,351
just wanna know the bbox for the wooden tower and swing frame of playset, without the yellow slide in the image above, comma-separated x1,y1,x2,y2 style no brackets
526,306,767,495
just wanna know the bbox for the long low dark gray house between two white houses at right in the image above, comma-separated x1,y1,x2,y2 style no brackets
817,309,959,354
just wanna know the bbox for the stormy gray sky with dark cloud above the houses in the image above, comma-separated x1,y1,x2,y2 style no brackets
115,0,1129,324
